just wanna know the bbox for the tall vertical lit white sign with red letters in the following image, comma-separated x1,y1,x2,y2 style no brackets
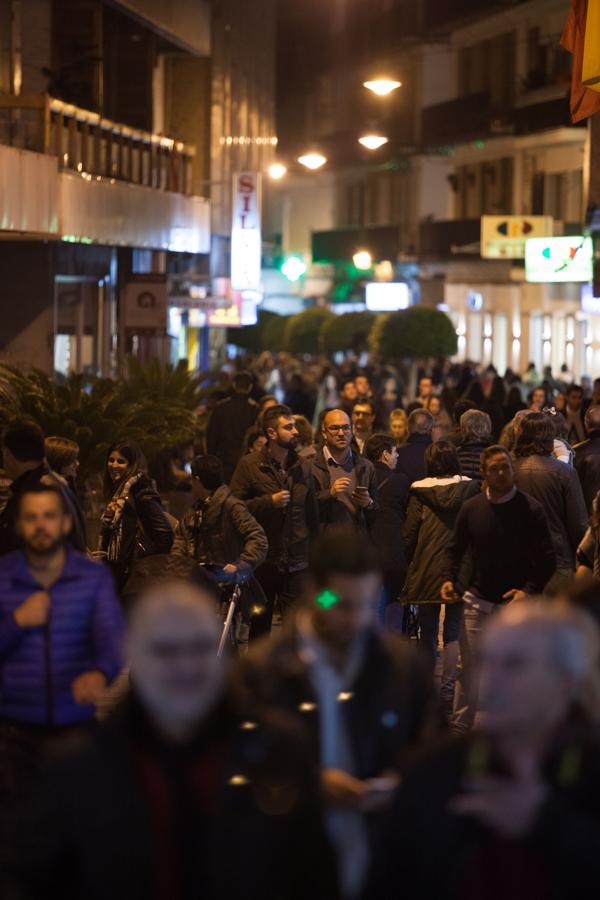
231,172,262,291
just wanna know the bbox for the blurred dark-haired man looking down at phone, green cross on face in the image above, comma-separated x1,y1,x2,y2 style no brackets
241,528,437,897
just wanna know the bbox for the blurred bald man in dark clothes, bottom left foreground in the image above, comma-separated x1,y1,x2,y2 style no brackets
15,581,337,900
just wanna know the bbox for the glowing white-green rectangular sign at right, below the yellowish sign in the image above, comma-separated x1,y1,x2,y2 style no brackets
525,235,594,283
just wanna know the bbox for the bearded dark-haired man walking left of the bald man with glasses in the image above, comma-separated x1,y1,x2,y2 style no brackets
230,406,319,640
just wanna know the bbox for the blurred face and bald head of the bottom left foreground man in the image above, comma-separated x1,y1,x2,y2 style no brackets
129,584,224,730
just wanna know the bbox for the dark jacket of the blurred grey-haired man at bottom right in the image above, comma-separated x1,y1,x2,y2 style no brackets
365,736,600,900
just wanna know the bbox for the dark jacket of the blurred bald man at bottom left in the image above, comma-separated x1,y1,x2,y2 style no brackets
16,700,338,900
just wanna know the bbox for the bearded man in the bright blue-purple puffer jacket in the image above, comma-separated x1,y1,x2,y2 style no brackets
0,484,123,880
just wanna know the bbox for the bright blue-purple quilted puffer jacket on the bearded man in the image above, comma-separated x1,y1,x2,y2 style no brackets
0,549,124,726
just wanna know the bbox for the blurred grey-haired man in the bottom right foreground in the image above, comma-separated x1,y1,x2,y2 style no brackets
367,603,600,900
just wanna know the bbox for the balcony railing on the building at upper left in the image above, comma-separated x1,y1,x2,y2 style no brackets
0,94,195,194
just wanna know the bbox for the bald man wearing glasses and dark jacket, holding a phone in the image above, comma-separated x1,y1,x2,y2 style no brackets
312,409,377,531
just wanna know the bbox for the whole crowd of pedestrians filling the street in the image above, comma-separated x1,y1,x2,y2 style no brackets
0,360,600,900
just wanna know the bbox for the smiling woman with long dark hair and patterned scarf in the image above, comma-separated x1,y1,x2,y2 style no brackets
99,440,173,592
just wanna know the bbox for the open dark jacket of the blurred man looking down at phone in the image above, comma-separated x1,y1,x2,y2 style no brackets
240,618,439,779
